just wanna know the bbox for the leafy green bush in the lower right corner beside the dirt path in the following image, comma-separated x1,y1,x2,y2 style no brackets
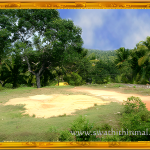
121,96,150,141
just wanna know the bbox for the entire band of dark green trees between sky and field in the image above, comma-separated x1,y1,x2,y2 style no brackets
0,9,150,88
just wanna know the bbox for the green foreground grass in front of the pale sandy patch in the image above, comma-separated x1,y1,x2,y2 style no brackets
0,103,124,141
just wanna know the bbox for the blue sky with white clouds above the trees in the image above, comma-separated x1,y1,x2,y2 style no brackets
58,9,150,51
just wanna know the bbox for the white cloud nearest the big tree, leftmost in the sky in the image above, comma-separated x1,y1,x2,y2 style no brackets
74,10,107,47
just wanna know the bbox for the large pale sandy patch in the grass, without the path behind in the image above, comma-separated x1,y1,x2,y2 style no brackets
4,94,110,118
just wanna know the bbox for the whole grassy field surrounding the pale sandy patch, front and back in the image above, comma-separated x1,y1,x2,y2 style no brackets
0,84,150,141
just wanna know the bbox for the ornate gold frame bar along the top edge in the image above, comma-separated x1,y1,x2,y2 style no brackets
0,0,150,9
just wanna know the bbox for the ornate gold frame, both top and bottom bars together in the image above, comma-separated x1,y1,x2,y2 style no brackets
0,0,150,149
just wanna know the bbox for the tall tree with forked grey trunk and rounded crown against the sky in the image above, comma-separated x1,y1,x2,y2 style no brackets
14,19,83,88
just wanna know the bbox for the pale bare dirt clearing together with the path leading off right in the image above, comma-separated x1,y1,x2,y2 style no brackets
4,87,150,118
